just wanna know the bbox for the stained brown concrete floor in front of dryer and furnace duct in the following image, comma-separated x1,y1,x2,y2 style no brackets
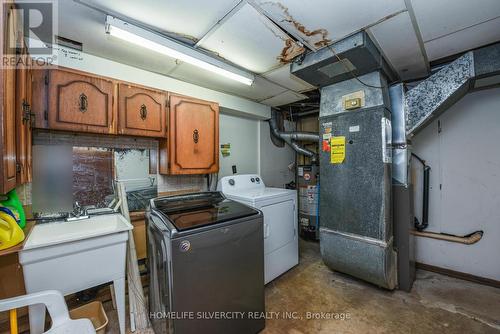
105,241,500,334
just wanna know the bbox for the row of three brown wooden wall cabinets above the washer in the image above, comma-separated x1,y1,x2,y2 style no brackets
28,68,219,174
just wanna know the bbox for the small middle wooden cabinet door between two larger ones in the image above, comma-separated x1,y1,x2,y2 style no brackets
118,83,167,137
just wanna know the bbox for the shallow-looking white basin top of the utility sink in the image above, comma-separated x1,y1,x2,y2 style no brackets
24,213,133,250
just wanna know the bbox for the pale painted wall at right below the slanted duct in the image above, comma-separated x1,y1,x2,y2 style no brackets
413,88,500,280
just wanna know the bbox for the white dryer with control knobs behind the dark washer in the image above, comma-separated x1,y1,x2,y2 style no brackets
217,174,299,284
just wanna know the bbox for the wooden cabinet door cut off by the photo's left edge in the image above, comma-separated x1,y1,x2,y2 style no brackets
0,3,16,194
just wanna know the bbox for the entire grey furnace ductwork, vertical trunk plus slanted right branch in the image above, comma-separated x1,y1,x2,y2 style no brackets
290,31,500,289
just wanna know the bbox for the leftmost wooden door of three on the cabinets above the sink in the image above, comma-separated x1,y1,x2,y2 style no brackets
47,70,116,133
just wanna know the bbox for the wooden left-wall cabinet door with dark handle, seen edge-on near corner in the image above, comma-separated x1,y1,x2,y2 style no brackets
16,49,34,184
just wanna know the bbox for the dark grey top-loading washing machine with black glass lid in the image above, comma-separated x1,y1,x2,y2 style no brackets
146,192,265,334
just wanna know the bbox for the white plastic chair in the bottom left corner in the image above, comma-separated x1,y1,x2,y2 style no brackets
0,290,95,334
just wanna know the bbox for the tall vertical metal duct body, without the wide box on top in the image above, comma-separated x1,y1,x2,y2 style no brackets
319,72,397,289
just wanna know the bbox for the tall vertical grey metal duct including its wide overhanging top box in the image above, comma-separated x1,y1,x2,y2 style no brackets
291,32,397,289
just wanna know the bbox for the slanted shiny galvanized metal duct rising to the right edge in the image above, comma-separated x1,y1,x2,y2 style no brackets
405,43,500,135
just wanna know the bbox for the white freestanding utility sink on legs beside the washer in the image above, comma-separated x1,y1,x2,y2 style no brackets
19,214,133,334
